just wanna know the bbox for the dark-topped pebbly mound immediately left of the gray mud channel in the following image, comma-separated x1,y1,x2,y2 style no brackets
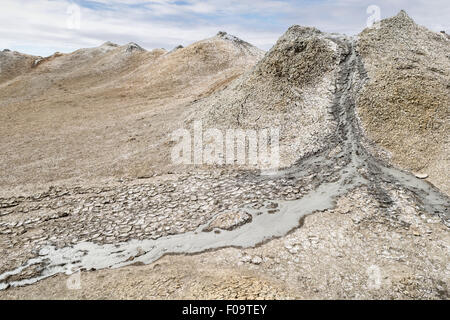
190,26,339,166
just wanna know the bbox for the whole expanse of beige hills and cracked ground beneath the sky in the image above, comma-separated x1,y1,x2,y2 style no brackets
0,12,450,300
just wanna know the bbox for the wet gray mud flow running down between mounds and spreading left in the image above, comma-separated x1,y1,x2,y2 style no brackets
0,35,450,289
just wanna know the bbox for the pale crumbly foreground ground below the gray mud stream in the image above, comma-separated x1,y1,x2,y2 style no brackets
0,185,450,299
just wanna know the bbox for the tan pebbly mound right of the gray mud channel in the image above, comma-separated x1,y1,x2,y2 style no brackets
358,11,450,193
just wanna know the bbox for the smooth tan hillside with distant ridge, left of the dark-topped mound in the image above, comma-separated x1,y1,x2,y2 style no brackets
0,35,263,191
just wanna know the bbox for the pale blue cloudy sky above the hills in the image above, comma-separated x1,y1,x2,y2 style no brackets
0,0,450,56
